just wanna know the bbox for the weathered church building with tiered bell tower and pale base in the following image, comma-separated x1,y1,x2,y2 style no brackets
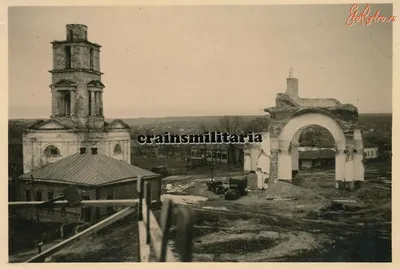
23,24,131,173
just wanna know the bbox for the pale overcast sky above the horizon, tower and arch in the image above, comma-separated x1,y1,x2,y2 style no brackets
9,5,392,118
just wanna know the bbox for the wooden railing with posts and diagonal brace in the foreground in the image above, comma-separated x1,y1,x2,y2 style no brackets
9,177,195,263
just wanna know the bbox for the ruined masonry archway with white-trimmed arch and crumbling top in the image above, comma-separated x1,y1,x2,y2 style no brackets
244,73,364,190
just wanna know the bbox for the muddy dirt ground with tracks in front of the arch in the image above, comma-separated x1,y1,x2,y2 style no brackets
10,163,392,262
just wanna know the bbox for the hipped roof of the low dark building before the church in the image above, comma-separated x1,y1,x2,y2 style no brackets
19,152,159,186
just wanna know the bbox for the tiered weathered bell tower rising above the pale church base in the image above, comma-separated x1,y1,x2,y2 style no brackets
49,24,105,129
